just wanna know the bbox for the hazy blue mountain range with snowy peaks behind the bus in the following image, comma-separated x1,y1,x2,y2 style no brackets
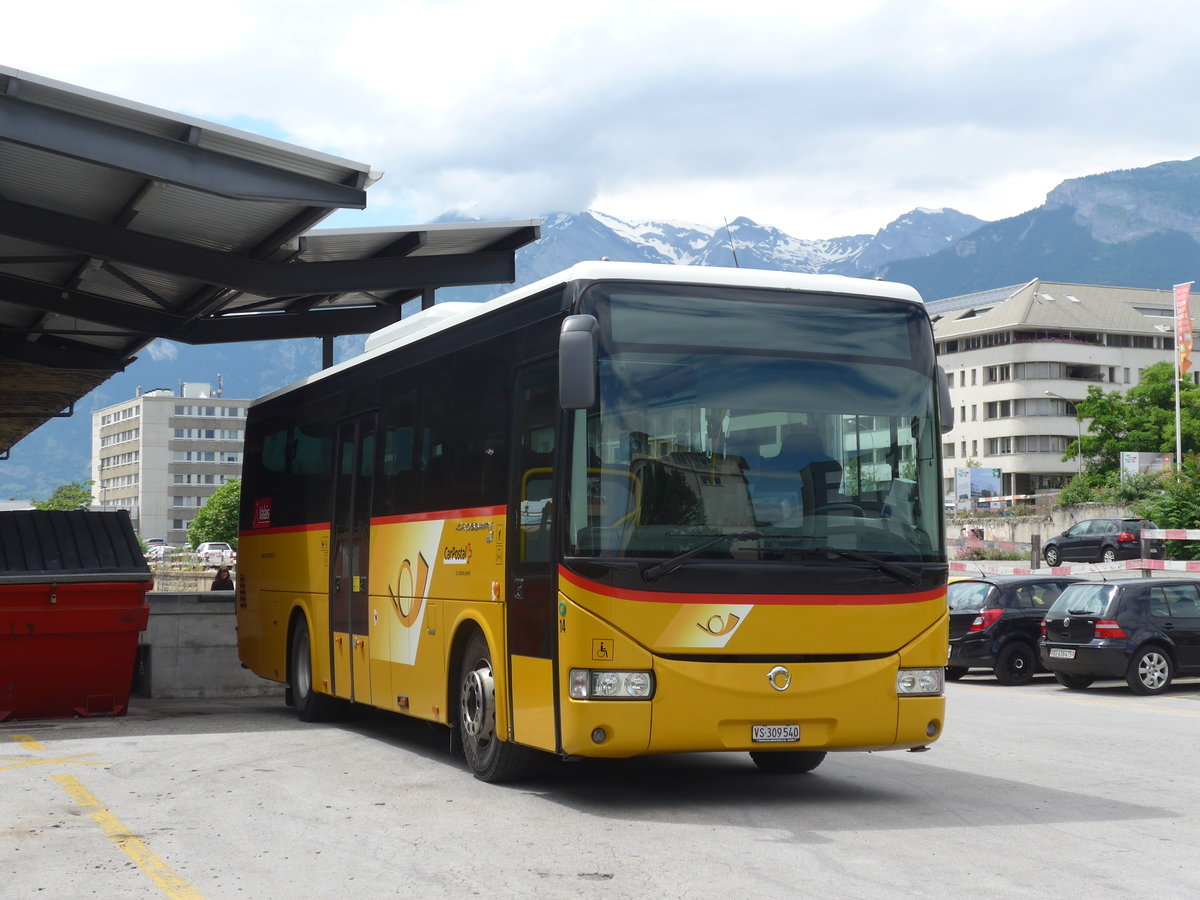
7,157,1200,500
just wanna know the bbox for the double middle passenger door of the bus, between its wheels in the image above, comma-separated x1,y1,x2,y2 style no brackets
329,413,376,703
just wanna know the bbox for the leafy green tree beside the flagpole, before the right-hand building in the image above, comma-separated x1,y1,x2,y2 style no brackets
1062,362,1200,474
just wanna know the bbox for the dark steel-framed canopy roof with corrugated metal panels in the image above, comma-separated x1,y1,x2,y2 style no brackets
0,66,539,458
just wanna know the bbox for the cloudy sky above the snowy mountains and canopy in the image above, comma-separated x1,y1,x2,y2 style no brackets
0,0,1200,239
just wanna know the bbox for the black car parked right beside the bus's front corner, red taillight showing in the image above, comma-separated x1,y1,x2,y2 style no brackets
946,575,1082,684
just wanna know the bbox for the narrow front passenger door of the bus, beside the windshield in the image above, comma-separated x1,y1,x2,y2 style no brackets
505,361,558,750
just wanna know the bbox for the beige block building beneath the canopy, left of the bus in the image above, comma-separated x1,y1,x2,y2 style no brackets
91,383,251,546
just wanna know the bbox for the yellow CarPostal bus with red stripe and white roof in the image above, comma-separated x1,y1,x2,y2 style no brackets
238,260,950,781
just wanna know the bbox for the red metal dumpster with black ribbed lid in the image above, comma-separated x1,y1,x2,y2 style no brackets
0,510,152,721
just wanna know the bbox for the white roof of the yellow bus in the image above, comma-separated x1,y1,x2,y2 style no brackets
254,259,923,404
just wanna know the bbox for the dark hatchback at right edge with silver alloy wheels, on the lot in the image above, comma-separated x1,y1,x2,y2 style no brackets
1038,578,1200,694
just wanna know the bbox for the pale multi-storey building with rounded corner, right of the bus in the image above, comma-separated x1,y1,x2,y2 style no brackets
925,278,1180,497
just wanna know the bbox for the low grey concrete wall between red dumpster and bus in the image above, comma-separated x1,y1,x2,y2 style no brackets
133,592,283,697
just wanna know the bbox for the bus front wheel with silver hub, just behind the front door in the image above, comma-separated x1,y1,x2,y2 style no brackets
458,631,534,784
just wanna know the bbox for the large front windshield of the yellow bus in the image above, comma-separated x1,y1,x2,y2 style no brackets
568,284,943,562
